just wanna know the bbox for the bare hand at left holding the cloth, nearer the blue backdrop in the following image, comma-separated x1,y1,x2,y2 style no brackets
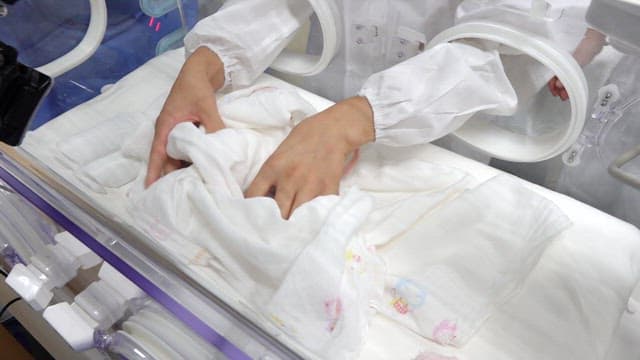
144,47,224,187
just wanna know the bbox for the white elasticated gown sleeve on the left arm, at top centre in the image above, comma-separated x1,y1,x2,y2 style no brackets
184,0,312,89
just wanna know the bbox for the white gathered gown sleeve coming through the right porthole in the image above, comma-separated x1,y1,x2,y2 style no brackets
359,43,517,146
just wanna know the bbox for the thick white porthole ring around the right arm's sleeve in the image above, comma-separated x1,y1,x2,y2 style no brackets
430,21,587,162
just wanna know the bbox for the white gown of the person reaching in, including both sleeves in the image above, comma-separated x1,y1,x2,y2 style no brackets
185,0,516,145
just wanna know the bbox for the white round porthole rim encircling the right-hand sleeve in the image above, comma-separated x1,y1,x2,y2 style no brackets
429,20,588,162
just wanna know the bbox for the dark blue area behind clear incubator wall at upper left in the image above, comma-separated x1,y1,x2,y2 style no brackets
0,0,198,129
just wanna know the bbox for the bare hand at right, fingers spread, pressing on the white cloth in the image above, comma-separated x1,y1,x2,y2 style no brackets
245,97,375,219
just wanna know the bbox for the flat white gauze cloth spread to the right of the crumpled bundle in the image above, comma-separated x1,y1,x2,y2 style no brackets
380,175,571,346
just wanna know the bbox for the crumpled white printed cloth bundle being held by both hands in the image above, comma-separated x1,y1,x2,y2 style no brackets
130,89,466,358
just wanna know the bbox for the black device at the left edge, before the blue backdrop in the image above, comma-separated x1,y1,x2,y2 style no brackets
0,41,52,146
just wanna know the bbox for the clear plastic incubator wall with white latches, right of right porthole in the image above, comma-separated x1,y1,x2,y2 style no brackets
484,0,640,226
